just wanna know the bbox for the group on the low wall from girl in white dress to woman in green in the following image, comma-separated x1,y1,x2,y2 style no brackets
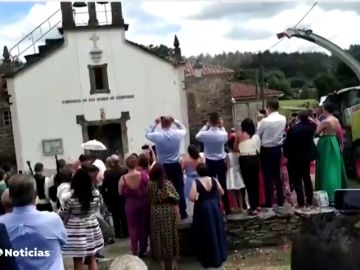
217,100,347,215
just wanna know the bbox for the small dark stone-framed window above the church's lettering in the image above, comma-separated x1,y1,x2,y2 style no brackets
88,64,110,94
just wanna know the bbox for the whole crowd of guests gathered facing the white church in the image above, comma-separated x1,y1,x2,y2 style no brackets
0,97,346,270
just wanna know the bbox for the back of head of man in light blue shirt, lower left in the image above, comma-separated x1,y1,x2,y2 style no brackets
9,174,36,207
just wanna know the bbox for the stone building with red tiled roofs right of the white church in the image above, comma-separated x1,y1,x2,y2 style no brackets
185,61,280,143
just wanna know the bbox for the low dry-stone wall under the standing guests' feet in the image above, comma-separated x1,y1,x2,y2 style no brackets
179,210,336,256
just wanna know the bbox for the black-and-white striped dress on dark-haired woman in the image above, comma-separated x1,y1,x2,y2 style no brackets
62,189,104,257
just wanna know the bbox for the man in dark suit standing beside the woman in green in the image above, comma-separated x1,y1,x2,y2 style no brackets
284,111,317,207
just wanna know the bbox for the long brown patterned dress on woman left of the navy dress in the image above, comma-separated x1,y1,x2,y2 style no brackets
149,180,179,261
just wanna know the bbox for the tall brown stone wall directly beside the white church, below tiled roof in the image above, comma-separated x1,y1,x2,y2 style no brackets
185,74,233,143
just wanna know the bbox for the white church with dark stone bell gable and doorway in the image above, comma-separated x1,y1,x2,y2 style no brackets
7,2,188,170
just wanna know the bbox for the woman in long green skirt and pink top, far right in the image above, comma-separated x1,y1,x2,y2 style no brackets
315,103,347,202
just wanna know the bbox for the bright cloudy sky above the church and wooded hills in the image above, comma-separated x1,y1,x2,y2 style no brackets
0,0,360,56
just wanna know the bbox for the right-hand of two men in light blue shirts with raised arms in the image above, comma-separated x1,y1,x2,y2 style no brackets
195,113,231,215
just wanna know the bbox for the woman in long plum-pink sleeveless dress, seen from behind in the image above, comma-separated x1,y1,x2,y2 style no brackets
119,155,150,257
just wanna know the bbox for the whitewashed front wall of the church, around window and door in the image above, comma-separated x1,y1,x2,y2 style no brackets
9,29,189,169
